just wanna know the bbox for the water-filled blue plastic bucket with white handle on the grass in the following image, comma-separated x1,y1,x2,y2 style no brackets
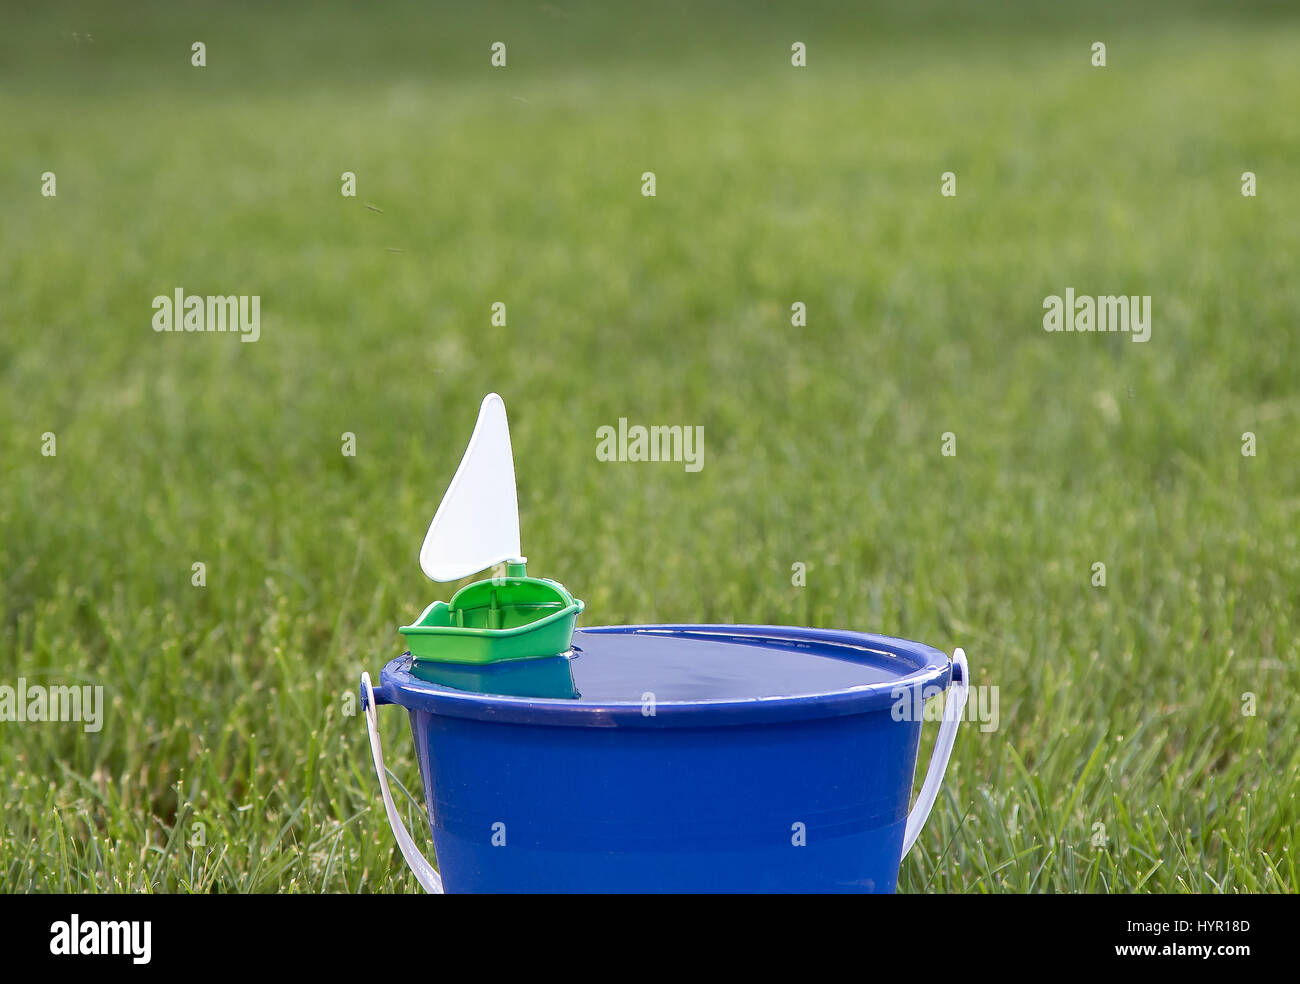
363,625,969,892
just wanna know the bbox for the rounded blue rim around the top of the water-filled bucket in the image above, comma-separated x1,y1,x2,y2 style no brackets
374,624,953,728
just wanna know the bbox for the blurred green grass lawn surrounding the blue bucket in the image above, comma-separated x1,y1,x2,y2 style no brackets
0,0,1300,892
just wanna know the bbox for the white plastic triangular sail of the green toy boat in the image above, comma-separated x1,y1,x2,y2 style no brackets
420,393,523,581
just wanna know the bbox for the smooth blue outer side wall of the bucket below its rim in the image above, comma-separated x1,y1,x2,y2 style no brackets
410,696,920,893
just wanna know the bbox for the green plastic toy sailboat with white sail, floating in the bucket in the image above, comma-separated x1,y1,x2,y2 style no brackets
399,393,582,666
